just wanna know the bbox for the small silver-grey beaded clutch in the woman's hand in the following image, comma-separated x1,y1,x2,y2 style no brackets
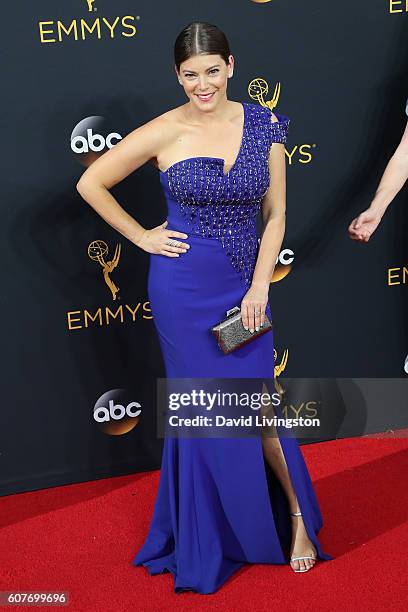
211,306,272,355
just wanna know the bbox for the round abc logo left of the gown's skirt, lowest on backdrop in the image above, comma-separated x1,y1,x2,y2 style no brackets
93,389,142,436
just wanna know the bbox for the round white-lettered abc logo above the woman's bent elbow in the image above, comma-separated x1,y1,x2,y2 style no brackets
70,116,122,167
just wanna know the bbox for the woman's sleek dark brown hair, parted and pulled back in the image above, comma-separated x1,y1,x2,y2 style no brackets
174,21,231,70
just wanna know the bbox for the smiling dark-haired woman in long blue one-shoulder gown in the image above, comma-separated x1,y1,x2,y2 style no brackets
78,22,330,593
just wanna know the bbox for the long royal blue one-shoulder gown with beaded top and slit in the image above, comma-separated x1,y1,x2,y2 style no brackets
132,102,331,593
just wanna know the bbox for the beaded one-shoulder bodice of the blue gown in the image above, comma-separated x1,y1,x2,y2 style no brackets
160,102,290,290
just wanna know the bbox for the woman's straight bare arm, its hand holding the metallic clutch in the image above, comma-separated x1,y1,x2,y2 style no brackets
241,114,286,332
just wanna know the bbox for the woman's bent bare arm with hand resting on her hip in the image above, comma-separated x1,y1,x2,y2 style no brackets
76,117,187,257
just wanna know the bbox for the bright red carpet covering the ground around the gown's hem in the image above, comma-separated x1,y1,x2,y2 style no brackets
0,438,408,612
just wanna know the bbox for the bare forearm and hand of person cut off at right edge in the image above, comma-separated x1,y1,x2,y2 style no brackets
348,100,408,242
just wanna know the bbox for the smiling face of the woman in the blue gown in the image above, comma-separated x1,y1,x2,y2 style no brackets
176,55,234,110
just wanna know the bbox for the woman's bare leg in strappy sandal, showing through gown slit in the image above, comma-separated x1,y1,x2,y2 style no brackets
261,384,316,570
